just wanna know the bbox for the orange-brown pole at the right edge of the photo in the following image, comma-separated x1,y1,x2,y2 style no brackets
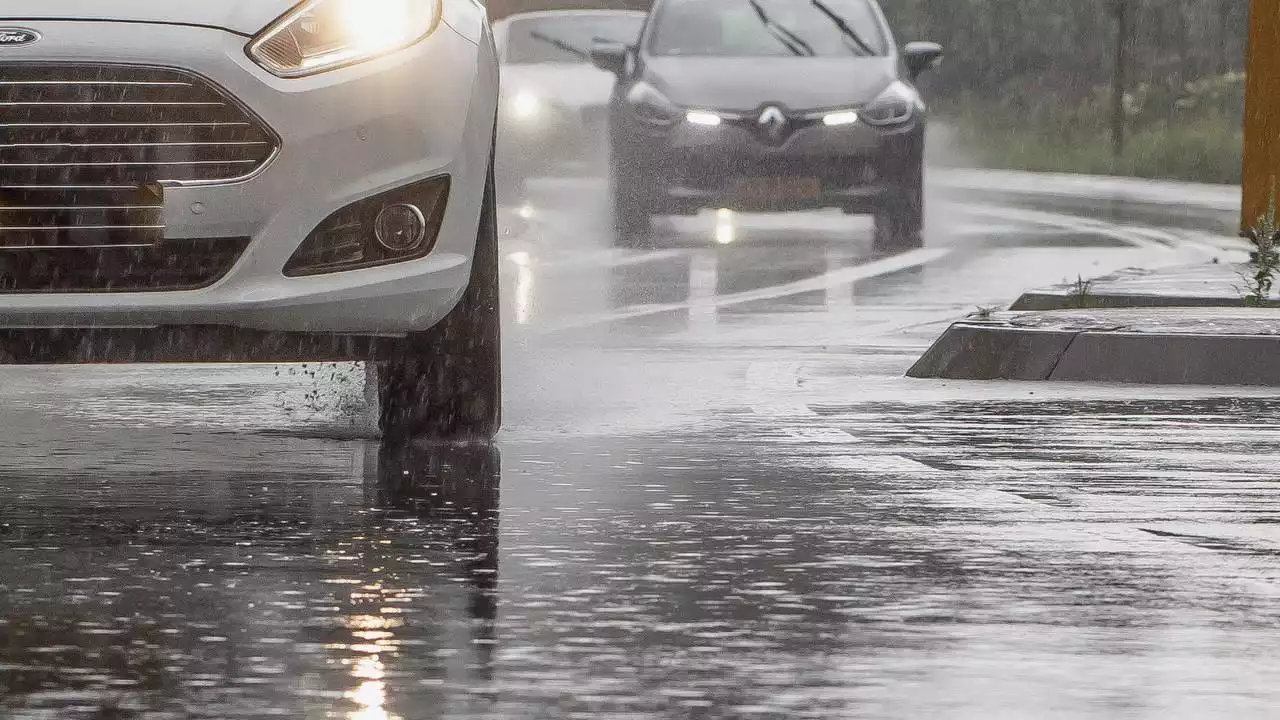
1242,0,1280,227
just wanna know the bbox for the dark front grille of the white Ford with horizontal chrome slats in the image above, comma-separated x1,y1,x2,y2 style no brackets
0,63,278,292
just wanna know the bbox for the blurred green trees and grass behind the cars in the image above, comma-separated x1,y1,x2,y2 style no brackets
490,0,1249,182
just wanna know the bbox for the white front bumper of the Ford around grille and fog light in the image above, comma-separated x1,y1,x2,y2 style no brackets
0,20,497,334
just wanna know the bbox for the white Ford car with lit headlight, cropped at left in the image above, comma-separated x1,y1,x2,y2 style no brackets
0,0,500,438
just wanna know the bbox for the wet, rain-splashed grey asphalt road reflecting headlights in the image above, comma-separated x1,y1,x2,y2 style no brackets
0,174,1280,720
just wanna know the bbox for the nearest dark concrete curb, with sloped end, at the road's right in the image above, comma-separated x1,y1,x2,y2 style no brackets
908,323,1280,387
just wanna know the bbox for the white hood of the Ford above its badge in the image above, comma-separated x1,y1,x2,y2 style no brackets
0,0,298,35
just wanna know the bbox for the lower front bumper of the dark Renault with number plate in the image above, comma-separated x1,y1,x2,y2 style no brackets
617,118,924,214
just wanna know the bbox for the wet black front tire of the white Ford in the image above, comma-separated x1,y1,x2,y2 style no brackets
378,165,502,442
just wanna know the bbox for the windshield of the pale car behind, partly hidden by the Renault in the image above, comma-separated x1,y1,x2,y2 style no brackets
507,14,644,65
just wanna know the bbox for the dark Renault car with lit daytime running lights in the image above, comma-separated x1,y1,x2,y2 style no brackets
593,0,942,250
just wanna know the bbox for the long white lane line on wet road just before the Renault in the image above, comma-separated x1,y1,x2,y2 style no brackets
544,247,951,333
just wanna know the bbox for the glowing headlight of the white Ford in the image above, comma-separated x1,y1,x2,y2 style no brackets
248,0,440,77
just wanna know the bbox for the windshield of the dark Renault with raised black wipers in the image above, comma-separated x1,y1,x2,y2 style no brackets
649,0,887,58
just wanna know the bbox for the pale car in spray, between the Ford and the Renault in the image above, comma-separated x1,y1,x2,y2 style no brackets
494,10,645,200
